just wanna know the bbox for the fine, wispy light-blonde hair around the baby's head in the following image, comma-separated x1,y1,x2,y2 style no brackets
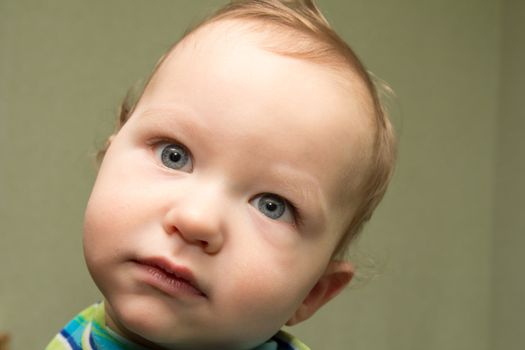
97,0,396,258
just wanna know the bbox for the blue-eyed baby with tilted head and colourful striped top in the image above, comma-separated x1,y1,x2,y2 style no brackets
47,0,395,350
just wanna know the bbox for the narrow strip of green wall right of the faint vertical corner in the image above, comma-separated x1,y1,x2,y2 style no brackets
491,0,525,350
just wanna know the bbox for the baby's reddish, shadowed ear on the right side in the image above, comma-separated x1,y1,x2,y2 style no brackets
286,260,354,326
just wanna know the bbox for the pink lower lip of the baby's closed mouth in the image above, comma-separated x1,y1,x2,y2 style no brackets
136,263,206,298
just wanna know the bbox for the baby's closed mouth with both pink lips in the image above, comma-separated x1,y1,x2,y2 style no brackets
133,258,207,298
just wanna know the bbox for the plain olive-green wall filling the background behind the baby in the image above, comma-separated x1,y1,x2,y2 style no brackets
0,0,525,350
